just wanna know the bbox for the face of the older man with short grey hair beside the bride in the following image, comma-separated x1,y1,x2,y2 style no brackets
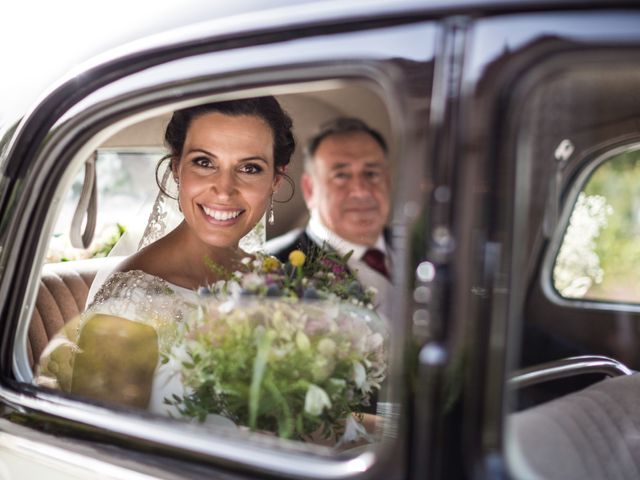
302,132,390,245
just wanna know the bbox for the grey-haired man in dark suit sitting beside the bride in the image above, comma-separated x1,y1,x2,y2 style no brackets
267,117,391,313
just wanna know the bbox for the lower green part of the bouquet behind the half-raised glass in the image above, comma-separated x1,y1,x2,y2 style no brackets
165,288,386,439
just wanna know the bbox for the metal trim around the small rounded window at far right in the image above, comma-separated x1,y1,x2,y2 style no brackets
539,136,640,313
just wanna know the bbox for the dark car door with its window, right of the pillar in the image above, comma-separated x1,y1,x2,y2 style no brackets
427,8,640,478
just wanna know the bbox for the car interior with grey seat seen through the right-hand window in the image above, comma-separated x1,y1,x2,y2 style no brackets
507,56,640,478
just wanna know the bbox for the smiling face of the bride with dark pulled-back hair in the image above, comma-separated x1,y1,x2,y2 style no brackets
174,112,282,247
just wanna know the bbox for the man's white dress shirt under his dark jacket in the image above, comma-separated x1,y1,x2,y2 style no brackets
306,210,392,318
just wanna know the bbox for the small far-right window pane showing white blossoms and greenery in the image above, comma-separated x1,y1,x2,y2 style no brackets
553,149,640,303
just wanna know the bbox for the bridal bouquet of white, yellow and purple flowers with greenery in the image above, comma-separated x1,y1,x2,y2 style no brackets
165,251,386,442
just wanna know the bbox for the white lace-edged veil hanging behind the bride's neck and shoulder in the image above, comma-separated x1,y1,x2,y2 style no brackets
87,162,266,305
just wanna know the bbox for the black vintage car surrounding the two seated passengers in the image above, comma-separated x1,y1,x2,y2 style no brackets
0,0,640,480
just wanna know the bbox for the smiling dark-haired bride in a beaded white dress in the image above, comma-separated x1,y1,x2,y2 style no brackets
36,97,295,414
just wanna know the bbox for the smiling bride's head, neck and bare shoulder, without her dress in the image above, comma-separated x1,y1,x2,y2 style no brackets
119,97,295,289
